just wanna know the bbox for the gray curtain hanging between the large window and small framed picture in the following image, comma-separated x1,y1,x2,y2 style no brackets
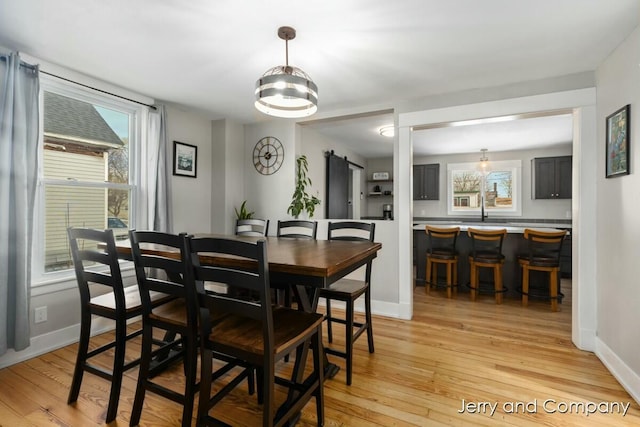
136,105,173,233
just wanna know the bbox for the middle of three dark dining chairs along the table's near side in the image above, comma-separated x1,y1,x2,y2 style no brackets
129,230,198,427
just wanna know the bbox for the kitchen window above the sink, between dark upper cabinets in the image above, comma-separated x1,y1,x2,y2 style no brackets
447,160,522,215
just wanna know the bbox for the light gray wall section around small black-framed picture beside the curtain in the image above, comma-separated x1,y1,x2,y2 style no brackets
166,105,212,233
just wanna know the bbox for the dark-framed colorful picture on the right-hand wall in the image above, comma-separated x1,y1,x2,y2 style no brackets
606,104,631,178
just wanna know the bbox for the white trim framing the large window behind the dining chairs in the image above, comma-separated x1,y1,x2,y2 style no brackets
31,74,149,293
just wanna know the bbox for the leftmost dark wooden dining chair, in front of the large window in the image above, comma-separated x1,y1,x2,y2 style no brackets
67,228,170,423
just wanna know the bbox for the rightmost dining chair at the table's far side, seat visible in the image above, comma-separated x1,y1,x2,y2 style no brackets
320,221,376,385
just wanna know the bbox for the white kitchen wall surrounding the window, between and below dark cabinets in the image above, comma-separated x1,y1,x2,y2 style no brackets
413,143,572,219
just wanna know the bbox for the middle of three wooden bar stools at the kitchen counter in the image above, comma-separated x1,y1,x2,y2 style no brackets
467,227,507,304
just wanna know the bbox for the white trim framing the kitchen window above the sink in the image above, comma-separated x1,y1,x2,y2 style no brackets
447,160,522,217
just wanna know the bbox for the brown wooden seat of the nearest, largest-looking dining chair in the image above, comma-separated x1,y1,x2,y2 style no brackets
209,307,324,356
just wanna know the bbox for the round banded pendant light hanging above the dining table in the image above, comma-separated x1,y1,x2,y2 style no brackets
255,27,318,118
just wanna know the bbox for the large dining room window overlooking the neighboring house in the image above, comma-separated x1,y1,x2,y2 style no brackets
33,79,142,282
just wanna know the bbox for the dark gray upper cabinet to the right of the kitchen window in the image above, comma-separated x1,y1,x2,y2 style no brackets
531,156,572,199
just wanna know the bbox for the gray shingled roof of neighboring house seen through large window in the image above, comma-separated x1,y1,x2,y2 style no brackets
44,91,124,147
